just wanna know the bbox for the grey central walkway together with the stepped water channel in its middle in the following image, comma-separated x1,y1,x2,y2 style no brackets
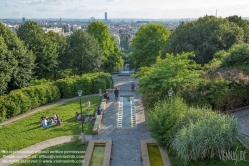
92,74,153,166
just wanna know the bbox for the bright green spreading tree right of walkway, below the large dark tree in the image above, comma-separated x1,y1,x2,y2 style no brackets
137,53,202,108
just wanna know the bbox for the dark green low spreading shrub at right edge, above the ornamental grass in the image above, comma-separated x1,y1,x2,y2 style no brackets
181,79,249,111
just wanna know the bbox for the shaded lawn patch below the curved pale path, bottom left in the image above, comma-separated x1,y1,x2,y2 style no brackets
12,141,87,166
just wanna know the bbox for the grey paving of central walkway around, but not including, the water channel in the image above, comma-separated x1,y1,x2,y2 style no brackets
93,75,152,166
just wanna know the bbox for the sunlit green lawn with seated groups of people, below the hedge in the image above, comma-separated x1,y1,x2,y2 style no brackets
0,96,102,158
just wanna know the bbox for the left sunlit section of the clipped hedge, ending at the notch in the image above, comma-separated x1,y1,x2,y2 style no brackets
0,84,61,121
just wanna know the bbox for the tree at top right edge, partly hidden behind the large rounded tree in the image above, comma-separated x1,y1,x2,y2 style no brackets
227,15,249,43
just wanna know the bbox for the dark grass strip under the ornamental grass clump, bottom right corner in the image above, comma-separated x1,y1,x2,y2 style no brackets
167,142,249,166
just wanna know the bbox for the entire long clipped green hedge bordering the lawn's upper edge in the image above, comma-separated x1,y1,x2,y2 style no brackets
0,72,113,122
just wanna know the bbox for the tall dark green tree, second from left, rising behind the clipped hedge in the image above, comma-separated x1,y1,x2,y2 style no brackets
17,21,58,78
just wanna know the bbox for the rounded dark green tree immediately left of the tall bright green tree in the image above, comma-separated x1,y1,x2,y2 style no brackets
67,30,103,74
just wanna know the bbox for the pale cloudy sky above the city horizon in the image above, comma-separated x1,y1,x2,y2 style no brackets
0,0,249,19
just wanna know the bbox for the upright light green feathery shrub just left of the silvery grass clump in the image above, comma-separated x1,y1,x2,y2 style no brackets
149,96,188,147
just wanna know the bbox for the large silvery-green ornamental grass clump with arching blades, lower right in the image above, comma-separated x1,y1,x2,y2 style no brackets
170,108,238,163
